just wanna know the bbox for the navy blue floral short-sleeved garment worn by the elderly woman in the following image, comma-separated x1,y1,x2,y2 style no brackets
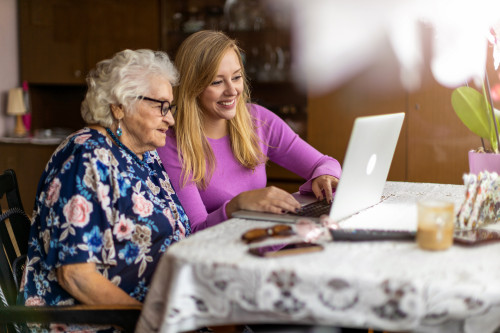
20,128,191,305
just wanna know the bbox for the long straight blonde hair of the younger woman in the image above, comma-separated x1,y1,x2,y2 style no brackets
174,30,266,189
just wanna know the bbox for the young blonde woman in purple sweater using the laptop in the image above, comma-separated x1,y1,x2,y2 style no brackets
157,31,341,231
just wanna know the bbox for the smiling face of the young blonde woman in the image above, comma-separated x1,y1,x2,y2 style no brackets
199,49,244,136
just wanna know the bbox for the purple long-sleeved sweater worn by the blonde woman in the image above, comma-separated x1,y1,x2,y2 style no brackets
157,104,341,231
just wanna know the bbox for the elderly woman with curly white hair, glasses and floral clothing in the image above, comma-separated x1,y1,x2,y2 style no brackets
20,50,191,314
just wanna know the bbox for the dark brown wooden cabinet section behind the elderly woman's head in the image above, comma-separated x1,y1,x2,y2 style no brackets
14,0,161,210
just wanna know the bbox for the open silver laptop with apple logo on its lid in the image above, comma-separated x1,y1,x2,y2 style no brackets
233,113,405,223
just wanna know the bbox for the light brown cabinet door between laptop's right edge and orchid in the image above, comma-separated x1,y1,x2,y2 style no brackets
406,68,481,184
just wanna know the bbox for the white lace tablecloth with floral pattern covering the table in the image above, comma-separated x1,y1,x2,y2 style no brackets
137,182,500,333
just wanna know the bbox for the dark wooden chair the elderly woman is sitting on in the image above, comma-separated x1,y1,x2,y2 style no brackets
0,169,142,332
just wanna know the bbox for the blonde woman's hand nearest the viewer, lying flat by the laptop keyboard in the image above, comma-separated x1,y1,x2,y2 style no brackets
226,186,300,217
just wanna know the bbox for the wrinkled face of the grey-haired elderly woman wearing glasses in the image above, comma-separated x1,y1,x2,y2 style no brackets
115,77,174,157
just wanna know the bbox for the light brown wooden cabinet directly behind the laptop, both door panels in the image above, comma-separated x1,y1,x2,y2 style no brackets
308,50,481,184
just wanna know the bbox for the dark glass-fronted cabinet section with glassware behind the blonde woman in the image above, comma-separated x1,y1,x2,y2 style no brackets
161,0,307,192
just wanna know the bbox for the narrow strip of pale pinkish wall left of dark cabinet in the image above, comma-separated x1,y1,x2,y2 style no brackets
0,0,20,136
